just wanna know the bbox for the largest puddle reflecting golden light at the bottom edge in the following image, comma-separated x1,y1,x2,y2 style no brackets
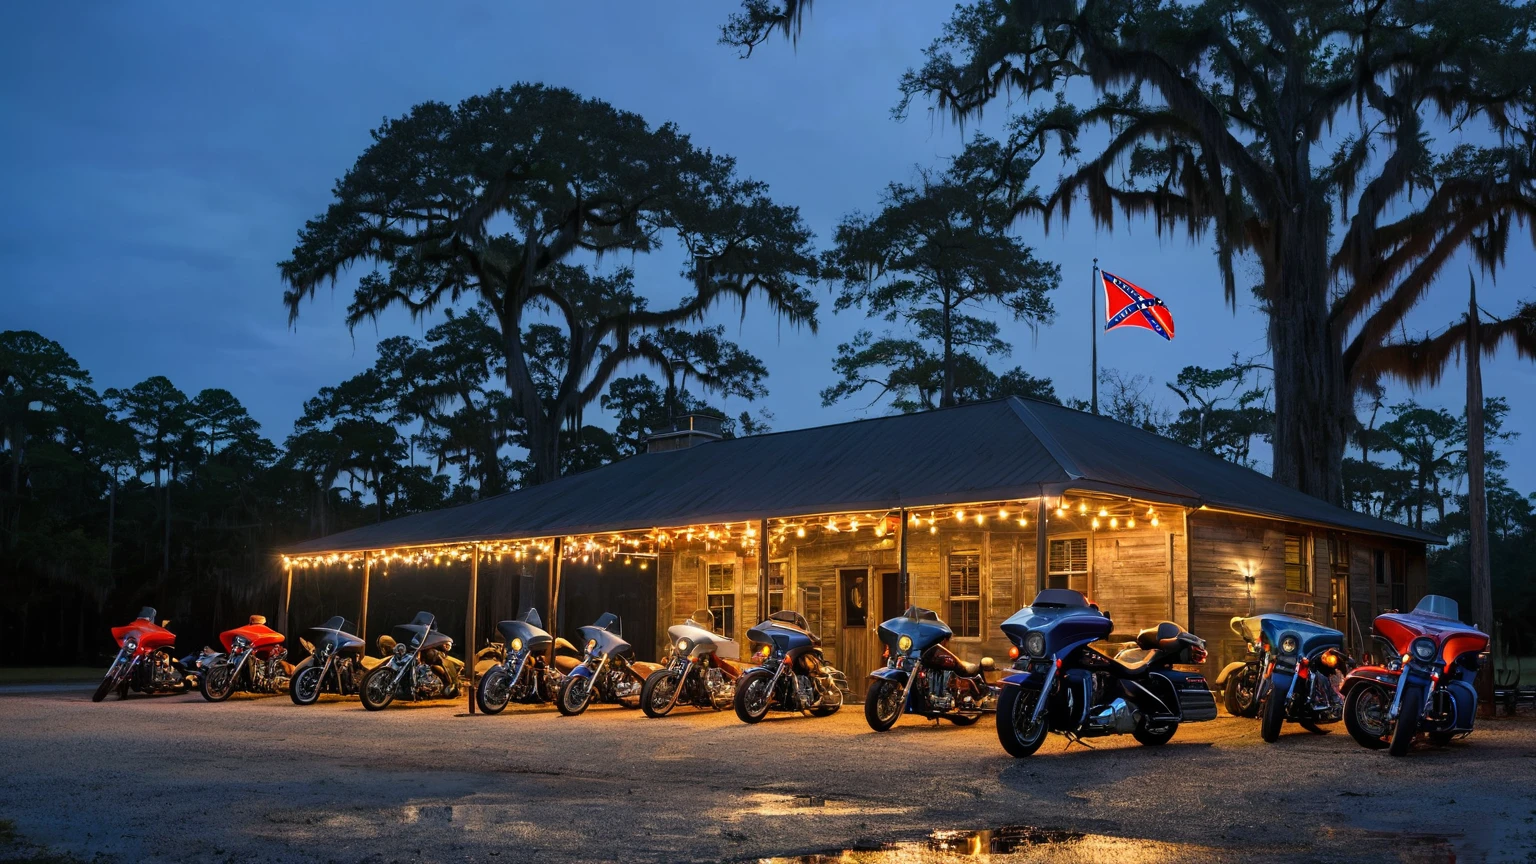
759,826,1232,864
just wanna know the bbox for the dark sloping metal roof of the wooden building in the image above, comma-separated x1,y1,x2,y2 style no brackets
284,397,1442,555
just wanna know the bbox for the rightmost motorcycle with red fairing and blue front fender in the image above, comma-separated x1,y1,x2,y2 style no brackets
1342,593,1488,756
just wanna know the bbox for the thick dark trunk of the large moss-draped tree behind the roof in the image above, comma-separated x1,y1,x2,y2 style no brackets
1269,208,1352,504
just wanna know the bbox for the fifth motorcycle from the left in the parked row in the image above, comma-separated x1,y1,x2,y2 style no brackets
475,609,581,713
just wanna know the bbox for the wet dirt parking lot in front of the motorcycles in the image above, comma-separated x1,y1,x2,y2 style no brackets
0,690,1536,864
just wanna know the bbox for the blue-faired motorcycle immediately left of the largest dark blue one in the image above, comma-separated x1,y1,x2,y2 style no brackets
865,606,997,732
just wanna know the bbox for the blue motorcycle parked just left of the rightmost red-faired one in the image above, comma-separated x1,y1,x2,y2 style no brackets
1243,612,1350,743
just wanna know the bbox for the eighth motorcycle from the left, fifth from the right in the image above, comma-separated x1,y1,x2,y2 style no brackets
736,609,848,723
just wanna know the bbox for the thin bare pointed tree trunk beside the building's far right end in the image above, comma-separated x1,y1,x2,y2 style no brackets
1467,283,1495,715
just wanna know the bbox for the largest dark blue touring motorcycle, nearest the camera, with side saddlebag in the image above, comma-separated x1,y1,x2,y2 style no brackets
997,589,1217,758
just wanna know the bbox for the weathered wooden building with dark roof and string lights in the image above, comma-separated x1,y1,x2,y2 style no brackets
286,398,1439,690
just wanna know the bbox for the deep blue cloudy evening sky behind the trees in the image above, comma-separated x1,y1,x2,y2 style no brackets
0,0,1536,492
